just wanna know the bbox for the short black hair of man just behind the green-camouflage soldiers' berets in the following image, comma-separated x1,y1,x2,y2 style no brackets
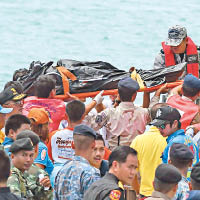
5,114,31,136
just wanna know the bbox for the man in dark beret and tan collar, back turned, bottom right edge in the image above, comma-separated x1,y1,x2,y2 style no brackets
146,164,181,200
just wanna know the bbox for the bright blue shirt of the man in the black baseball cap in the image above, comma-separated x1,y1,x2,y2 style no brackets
162,129,199,166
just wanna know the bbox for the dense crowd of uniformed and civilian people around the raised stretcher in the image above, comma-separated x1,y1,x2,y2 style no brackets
0,25,200,200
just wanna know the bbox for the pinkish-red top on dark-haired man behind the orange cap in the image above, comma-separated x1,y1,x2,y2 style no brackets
22,96,65,132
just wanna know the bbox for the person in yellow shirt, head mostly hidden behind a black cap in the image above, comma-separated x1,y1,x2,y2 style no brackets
130,103,167,198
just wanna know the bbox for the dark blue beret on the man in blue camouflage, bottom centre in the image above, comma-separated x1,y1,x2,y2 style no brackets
73,124,97,138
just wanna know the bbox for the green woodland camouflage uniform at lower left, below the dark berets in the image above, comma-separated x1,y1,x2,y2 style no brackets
8,164,53,200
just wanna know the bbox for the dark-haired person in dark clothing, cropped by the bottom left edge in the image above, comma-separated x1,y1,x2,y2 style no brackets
0,150,21,200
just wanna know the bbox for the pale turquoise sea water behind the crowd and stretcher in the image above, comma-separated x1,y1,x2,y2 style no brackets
0,0,200,103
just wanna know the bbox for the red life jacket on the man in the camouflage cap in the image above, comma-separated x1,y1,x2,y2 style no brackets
162,37,199,78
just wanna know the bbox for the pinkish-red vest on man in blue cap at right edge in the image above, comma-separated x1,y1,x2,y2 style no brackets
167,95,199,130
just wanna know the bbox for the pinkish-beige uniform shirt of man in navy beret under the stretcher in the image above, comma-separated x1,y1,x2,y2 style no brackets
92,102,150,149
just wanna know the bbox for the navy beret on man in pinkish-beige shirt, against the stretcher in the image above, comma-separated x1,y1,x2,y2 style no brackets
118,77,140,93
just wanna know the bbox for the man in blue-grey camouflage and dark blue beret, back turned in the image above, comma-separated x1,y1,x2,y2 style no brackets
54,124,100,200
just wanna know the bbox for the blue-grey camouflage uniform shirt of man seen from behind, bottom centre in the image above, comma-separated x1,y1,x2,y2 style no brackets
54,156,100,200
